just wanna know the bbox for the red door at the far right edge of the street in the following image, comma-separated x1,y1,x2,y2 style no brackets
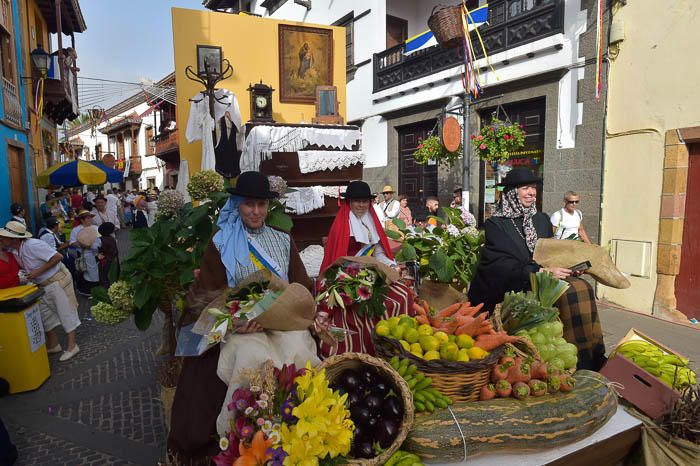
676,144,700,319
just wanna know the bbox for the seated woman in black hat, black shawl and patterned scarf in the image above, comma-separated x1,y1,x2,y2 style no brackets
469,168,605,370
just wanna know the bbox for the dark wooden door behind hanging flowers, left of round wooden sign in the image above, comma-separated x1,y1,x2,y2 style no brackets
398,120,438,219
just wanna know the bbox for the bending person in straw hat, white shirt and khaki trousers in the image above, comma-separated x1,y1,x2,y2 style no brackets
0,221,80,361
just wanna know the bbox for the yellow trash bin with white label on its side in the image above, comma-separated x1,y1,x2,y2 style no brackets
0,287,50,393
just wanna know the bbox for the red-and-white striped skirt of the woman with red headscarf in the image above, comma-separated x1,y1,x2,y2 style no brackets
320,282,414,358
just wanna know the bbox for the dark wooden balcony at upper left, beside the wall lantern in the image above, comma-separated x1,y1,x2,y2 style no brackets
44,49,80,125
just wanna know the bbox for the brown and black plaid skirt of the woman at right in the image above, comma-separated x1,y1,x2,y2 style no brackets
556,278,605,371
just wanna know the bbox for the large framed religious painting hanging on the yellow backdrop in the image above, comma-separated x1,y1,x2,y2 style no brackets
279,24,333,104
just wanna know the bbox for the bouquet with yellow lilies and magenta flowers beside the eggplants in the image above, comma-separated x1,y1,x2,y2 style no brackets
213,361,355,466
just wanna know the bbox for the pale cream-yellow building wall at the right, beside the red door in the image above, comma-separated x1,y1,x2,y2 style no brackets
601,0,700,313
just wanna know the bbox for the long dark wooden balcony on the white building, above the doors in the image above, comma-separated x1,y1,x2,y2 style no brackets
373,0,564,92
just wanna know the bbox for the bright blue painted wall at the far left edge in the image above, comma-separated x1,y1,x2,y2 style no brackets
0,0,33,230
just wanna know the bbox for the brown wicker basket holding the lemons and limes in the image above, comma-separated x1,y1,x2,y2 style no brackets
372,332,505,402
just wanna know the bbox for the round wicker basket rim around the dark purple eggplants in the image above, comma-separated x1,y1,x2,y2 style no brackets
318,353,413,466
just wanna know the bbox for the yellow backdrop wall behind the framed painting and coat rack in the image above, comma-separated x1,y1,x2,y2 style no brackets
172,8,346,173
